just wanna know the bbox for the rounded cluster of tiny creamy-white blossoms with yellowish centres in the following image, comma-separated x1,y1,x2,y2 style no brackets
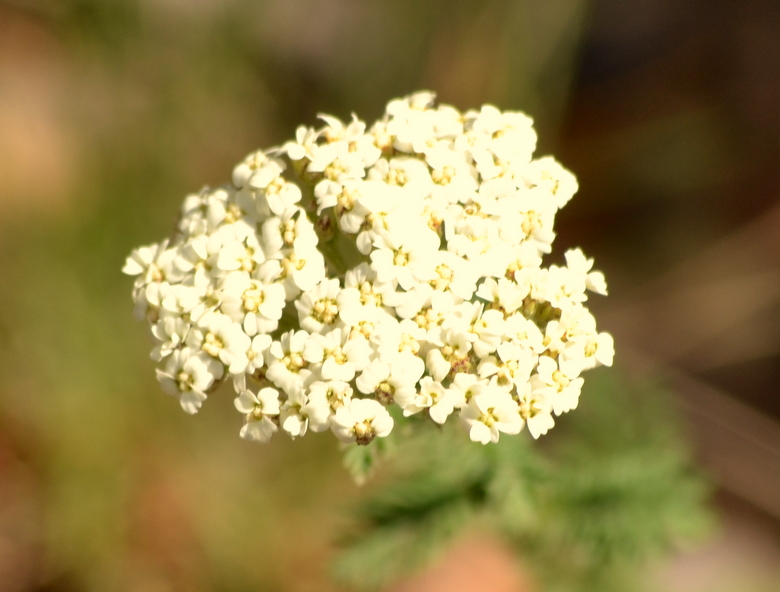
124,92,613,444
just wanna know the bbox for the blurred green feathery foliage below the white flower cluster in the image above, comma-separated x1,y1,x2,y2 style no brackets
334,373,710,592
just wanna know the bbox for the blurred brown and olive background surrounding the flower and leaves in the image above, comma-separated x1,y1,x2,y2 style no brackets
0,0,780,592
